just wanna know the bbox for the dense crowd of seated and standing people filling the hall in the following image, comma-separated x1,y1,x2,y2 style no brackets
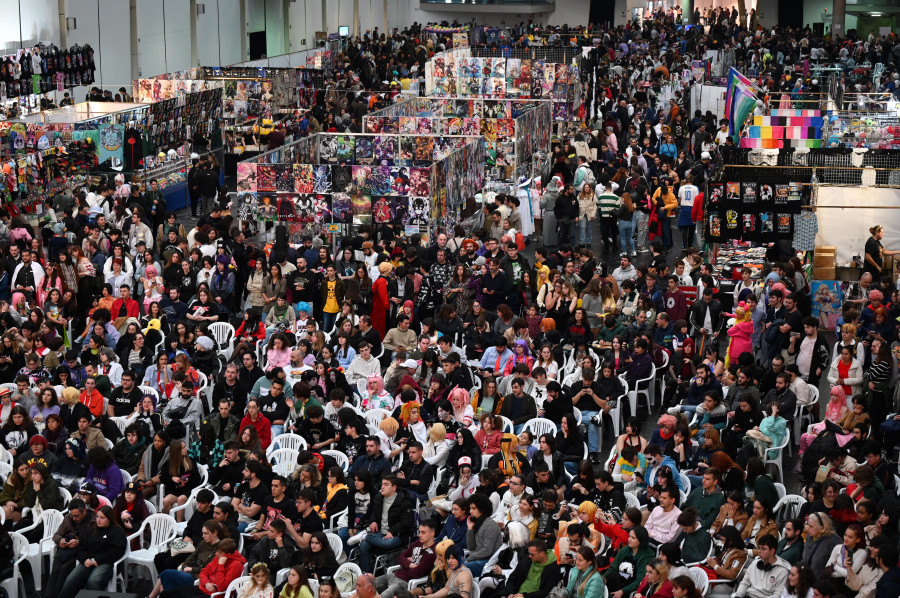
0,5,900,598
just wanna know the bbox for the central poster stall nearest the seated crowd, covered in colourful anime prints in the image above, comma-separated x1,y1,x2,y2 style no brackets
233,133,484,244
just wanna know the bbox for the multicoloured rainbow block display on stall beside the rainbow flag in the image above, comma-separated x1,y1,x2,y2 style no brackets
741,108,825,149
